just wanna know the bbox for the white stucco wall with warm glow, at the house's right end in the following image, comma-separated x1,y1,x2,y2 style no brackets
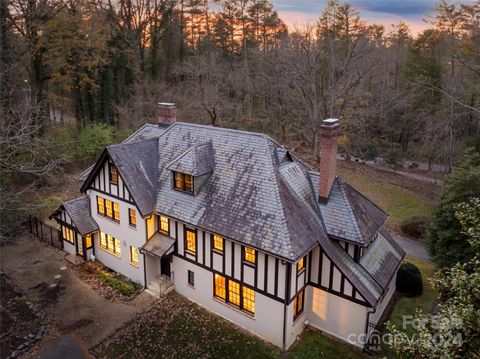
305,286,367,347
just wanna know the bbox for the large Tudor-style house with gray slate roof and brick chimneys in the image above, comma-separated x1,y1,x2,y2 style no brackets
52,103,404,349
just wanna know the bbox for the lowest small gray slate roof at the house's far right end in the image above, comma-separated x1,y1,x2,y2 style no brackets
360,230,405,288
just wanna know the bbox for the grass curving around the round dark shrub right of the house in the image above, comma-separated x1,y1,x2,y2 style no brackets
389,257,436,335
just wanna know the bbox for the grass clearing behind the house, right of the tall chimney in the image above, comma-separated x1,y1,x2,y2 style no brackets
341,171,434,225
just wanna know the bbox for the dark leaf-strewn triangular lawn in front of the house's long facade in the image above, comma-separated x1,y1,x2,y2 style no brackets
96,293,280,359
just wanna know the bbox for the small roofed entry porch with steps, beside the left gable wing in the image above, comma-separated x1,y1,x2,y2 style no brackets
141,232,175,297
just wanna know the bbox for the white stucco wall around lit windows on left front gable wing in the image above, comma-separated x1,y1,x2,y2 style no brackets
87,190,146,285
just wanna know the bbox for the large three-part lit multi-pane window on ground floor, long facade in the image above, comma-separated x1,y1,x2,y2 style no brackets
213,273,255,314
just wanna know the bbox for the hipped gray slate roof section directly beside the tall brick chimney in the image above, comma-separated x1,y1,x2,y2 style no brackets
310,176,388,246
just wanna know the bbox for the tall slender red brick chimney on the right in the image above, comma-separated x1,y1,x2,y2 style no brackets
318,118,340,203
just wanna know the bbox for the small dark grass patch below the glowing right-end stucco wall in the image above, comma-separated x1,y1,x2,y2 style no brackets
280,329,371,359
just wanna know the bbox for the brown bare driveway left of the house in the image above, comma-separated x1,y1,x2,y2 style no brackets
0,234,154,354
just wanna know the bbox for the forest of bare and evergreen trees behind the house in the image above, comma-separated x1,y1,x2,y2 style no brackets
0,0,480,233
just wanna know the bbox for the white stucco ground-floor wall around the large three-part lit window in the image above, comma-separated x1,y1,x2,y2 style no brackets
172,256,284,347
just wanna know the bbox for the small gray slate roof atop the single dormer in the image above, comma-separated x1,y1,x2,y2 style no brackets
167,141,215,176
